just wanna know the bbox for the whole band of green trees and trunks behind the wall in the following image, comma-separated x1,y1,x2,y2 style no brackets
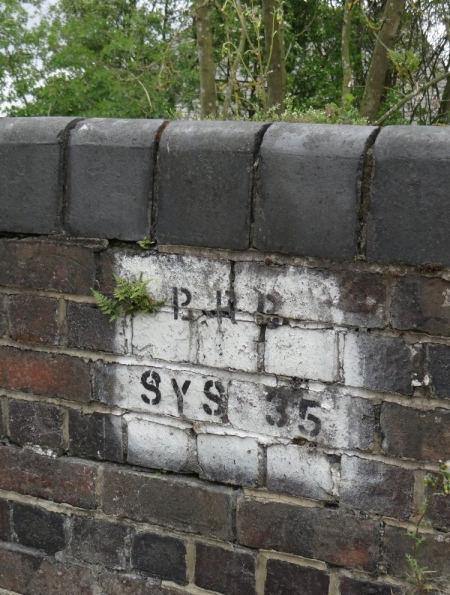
0,0,450,124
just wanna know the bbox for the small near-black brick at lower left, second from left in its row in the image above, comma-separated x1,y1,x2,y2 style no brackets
12,502,66,554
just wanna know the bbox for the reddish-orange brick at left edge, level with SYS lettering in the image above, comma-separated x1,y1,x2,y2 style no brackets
0,347,91,403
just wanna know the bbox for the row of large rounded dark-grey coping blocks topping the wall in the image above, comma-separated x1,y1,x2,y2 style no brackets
0,117,450,266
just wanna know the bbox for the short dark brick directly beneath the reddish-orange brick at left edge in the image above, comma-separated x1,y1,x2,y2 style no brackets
8,399,63,449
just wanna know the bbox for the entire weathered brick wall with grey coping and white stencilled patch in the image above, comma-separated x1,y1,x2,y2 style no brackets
0,118,450,595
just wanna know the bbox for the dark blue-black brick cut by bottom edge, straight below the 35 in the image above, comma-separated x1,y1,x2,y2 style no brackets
264,560,330,595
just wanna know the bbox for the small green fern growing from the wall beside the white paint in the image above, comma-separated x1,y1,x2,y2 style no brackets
91,273,165,322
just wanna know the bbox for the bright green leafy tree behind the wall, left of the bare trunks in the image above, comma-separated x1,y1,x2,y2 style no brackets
7,0,198,118
